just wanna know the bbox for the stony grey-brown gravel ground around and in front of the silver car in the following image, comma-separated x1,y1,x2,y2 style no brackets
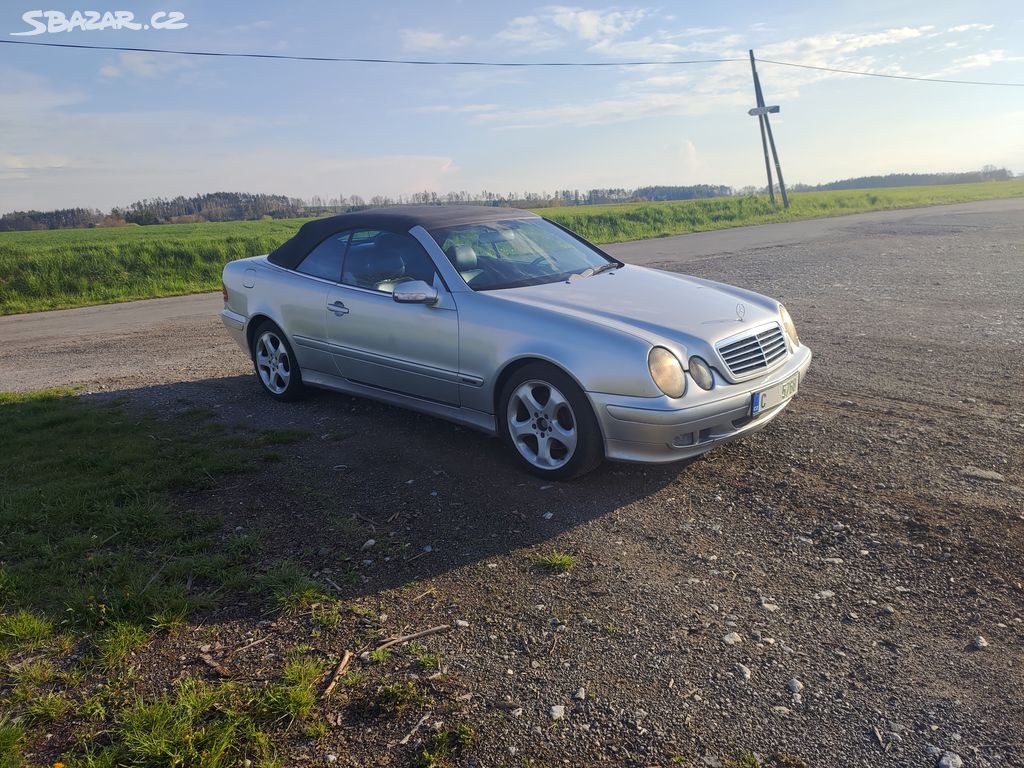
8,201,1024,766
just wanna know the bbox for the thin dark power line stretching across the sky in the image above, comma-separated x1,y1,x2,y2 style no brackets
0,39,1024,88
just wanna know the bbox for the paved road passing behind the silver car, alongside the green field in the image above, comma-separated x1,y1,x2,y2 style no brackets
0,199,1024,391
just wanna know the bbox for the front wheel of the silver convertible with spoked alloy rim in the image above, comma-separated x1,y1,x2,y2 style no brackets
496,362,604,480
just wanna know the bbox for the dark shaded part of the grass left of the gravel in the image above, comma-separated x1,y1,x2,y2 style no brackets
0,393,247,634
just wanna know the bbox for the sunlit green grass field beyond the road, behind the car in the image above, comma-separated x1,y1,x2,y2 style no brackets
0,179,1024,314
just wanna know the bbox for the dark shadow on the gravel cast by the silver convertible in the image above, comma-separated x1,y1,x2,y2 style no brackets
94,376,687,598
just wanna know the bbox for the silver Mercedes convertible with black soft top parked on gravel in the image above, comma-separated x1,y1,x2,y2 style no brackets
222,206,811,479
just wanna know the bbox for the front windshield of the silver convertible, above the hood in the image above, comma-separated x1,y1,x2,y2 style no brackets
430,219,617,291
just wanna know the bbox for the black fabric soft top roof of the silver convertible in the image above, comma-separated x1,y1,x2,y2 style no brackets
267,206,540,269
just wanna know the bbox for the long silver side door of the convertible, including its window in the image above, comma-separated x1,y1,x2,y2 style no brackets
327,229,459,404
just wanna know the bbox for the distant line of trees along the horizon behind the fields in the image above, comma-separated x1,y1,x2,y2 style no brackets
0,166,1014,231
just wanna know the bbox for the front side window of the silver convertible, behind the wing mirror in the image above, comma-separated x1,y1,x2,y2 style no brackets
341,229,434,293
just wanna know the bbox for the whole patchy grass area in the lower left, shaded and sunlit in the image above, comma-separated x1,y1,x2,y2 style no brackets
0,392,436,768
